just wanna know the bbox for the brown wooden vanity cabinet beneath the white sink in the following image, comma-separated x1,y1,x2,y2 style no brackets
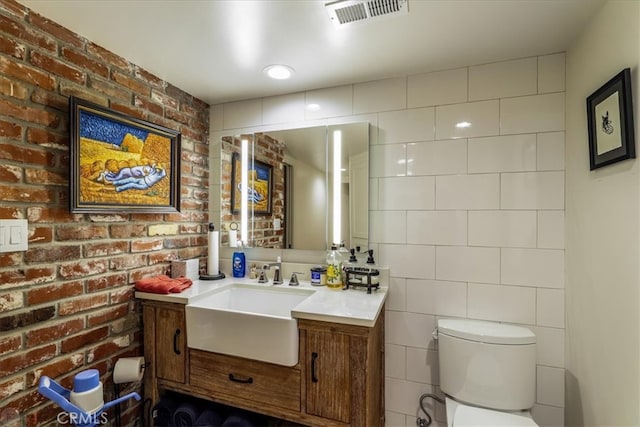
142,300,384,427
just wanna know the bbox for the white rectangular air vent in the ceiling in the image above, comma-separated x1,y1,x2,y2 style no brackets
325,0,409,27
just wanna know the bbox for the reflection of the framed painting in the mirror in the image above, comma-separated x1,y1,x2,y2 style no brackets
231,153,273,215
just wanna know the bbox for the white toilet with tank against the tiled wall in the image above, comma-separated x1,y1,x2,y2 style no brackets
434,319,537,427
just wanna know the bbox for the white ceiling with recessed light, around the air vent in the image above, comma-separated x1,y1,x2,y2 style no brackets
18,0,605,104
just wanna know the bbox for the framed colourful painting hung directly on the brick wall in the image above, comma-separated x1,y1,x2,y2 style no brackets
69,96,181,213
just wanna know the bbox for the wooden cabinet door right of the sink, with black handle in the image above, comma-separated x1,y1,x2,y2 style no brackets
306,330,351,423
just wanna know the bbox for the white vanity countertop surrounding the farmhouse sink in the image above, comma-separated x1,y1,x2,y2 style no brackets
135,277,388,327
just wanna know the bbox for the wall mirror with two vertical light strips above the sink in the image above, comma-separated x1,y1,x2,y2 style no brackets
220,123,369,251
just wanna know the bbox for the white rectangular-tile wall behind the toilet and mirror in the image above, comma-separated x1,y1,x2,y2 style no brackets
211,53,565,427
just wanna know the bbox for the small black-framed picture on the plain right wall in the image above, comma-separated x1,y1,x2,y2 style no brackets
587,68,636,170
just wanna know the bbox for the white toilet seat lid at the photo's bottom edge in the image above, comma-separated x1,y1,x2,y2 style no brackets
446,397,538,427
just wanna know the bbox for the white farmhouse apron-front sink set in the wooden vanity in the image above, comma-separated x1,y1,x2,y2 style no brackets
186,283,314,366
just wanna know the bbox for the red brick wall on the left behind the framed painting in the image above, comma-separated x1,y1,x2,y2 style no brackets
0,0,209,426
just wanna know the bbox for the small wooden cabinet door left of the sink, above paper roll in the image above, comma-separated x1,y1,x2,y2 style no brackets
155,307,187,383
